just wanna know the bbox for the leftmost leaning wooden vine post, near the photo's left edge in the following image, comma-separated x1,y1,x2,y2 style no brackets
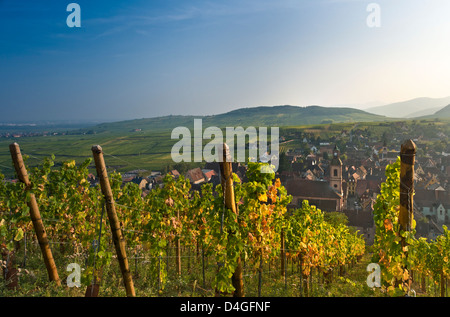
9,143,61,286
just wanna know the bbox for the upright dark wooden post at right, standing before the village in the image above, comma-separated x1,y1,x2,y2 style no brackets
398,140,416,289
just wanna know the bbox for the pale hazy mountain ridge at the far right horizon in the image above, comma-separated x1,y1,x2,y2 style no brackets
365,97,450,118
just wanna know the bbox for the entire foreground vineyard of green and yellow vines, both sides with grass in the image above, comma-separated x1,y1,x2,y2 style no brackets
0,139,450,296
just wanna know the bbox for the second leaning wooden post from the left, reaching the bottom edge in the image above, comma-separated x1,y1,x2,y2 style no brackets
92,145,136,297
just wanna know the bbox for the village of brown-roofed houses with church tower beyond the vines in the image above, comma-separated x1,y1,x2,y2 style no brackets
100,120,450,245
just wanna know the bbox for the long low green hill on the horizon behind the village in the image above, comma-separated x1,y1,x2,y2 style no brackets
93,105,389,131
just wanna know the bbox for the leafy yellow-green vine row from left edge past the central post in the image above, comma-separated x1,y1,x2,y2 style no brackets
0,145,365,296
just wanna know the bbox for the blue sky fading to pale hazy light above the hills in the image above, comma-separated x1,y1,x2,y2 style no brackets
0,0,450,123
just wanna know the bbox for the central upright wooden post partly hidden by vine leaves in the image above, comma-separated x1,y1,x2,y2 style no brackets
220,143,244,297
